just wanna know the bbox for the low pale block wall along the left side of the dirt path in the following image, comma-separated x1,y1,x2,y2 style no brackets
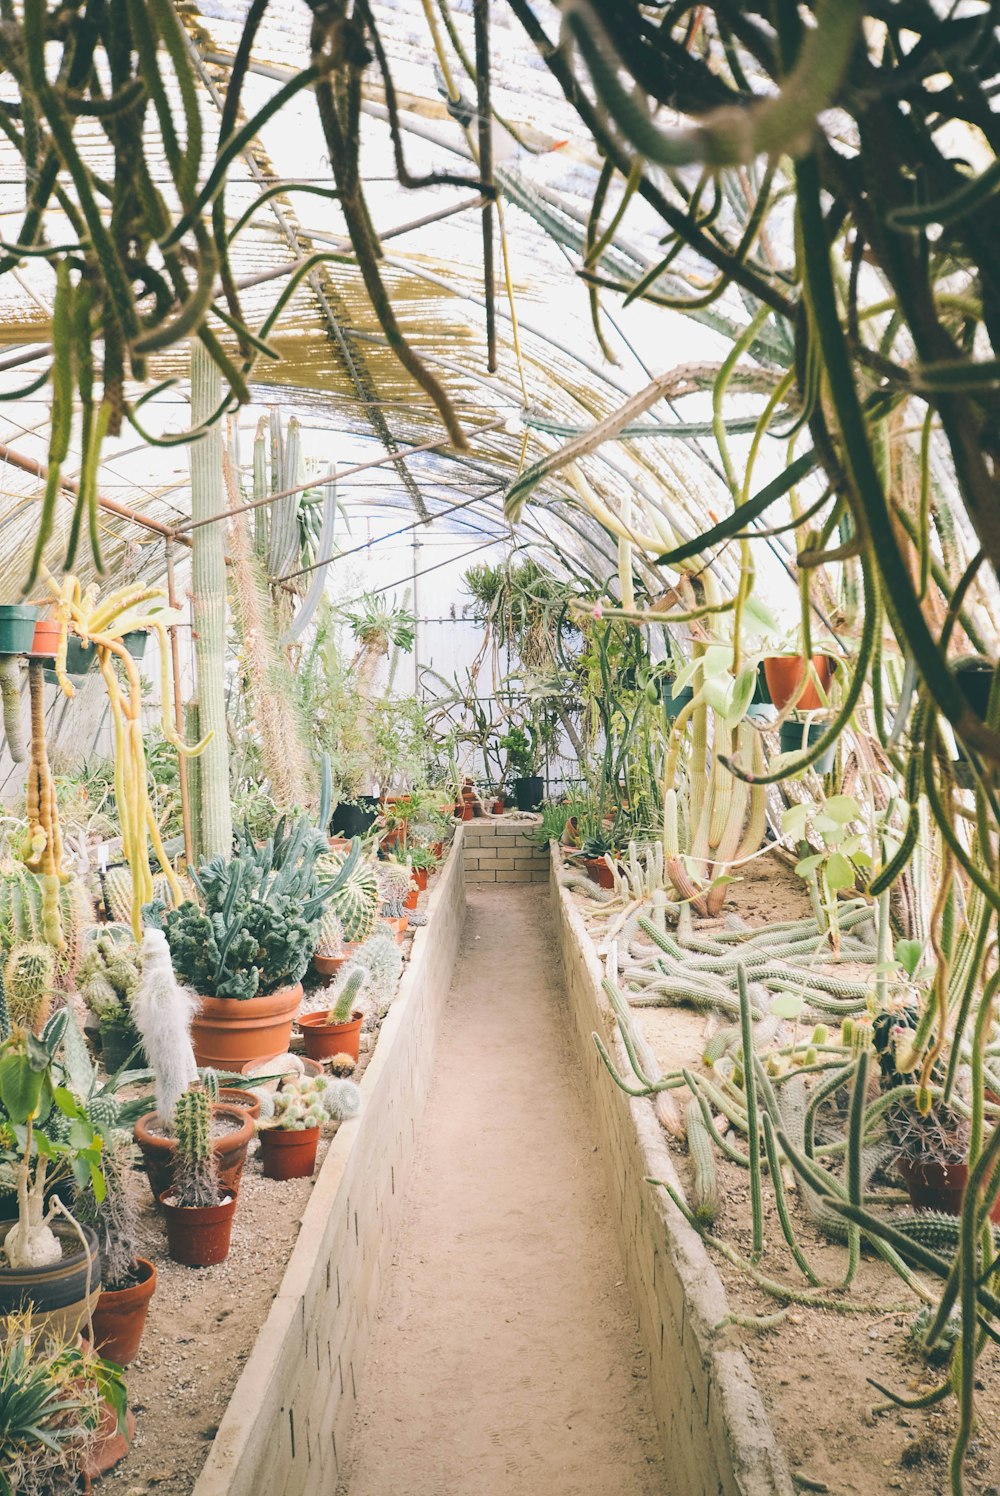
192,827,466,1496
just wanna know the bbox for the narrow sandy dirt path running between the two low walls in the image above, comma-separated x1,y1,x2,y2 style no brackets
338,886,671,1496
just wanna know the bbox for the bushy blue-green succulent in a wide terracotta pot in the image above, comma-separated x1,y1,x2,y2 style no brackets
163,817,369,1070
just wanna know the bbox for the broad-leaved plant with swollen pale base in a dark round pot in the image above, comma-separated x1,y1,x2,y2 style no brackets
0,1011,103,1334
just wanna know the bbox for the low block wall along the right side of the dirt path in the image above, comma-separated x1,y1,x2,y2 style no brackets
551,848,795,1496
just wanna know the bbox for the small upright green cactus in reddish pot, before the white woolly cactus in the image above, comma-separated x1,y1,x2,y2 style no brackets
160,1089,237,1267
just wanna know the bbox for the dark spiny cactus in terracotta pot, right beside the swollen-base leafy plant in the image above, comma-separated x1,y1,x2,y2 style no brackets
73,1131,156,1366
